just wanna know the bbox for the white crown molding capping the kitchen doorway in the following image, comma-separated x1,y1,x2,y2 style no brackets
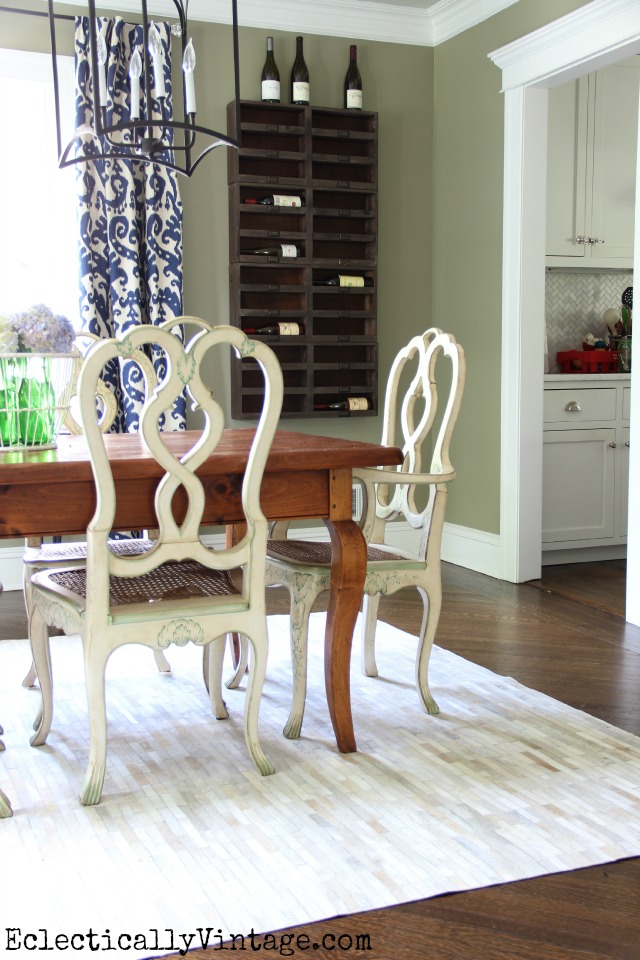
489,0,640,91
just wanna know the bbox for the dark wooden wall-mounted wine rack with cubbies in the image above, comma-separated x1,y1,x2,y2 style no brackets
227,100,378,420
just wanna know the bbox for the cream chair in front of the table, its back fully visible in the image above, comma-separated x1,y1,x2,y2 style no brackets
30,317,283,804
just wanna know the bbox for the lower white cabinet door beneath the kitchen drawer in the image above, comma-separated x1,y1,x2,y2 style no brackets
542,428,616,543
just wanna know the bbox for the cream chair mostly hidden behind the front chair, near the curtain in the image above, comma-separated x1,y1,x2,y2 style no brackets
22,332,171,687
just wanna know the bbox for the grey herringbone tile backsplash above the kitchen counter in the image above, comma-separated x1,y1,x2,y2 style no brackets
545,270,633,373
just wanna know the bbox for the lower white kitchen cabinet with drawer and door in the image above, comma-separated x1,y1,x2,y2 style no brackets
542,375,630,563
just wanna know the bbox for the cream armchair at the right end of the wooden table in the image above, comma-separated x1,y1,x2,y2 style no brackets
264,328,465,738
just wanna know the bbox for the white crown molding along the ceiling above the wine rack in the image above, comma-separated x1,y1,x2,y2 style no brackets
48,0,518,47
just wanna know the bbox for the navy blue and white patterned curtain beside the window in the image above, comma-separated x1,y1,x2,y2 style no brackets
75,17,186,433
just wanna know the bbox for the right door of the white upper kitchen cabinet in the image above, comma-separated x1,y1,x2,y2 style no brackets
587,57,640,266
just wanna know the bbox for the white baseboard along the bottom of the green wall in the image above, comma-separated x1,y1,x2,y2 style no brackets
0,523,500,590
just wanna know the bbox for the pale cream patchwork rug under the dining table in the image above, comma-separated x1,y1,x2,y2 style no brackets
0,614,640,960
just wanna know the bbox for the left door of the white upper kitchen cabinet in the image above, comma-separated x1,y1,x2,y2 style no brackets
546,77,589,258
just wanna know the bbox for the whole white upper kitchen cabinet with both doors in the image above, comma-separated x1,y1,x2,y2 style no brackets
546,56,640,269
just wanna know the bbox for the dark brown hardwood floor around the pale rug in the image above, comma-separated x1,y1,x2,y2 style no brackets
0,565,640,960
